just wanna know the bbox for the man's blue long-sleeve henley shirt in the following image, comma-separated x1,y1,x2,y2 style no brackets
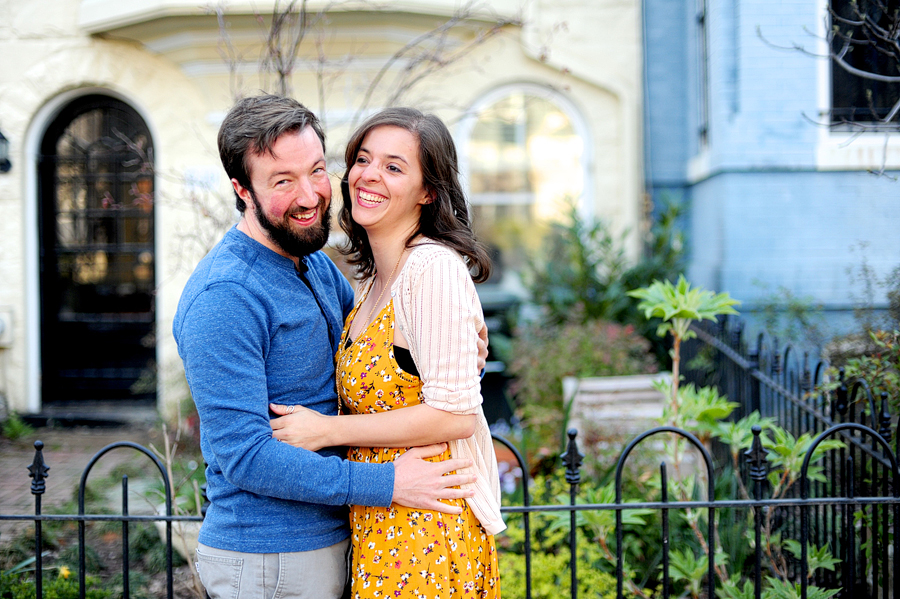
173,228,394,553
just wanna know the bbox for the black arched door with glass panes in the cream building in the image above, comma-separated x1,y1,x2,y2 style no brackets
38,95,156,405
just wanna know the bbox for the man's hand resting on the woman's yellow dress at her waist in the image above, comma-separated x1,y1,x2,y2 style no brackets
393,443,475,514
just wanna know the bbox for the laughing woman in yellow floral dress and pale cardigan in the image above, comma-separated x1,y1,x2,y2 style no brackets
276,108,505,599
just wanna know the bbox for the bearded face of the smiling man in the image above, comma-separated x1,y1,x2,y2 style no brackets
232,127,331,258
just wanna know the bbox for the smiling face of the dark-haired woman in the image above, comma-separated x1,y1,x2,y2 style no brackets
347,125,431,236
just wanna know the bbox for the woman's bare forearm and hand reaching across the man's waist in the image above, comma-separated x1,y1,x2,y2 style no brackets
269,404,476,451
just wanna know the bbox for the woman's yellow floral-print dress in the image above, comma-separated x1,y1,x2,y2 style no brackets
337,298,500,599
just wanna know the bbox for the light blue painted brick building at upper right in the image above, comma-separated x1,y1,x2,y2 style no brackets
644,0,900,340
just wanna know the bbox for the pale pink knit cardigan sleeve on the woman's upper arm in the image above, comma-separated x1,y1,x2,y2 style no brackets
401,249,484,413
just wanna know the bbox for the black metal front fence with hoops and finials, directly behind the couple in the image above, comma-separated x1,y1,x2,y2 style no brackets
0,423,900,599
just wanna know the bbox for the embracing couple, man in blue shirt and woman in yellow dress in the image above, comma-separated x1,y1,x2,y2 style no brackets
173,95,505,599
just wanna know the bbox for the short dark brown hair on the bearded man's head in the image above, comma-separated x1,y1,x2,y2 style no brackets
218,94,325,214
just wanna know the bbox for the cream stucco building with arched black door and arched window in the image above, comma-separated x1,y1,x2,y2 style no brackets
0,0,644,420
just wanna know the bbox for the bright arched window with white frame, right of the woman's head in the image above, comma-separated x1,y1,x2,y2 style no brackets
460,85,590,282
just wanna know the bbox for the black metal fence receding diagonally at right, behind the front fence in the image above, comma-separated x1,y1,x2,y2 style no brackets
683,318,900,597
